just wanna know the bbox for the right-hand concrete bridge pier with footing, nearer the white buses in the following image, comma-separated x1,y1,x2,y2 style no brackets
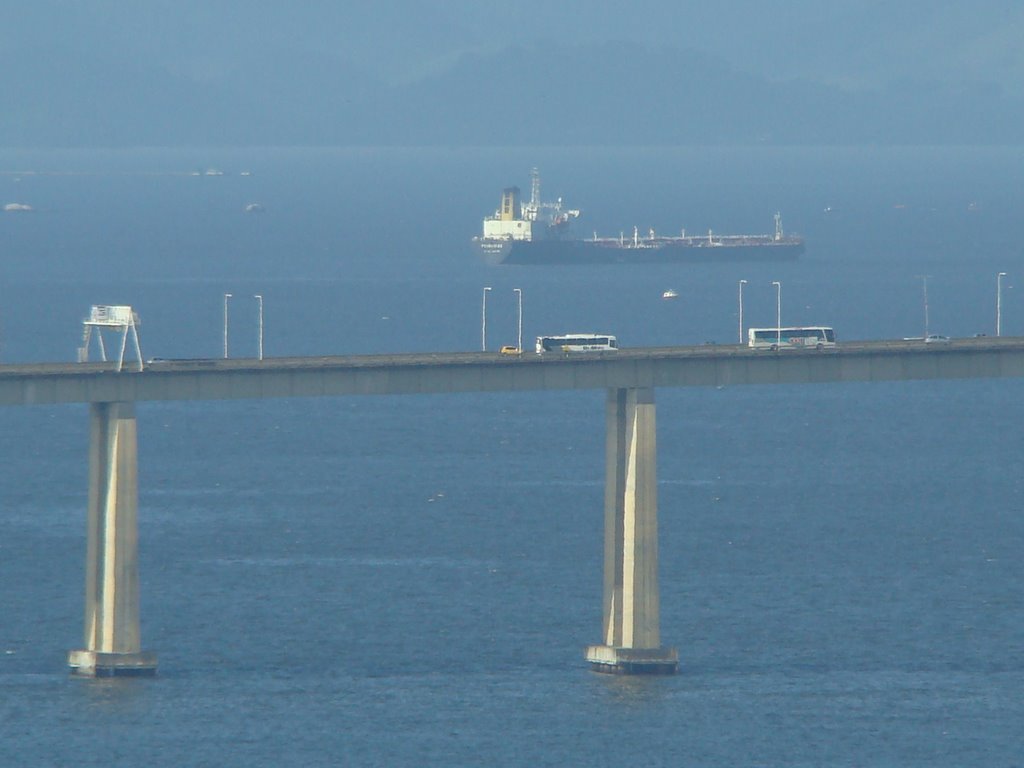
586,388,679,675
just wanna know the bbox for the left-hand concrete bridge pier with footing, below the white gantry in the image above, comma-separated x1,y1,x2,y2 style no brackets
68,402,157,677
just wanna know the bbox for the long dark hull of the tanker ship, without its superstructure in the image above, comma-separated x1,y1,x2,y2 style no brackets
473,236,804,265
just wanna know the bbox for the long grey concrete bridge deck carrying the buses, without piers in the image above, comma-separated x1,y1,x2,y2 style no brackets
0,337,1024,406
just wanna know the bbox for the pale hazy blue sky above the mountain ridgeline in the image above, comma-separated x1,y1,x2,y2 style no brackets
8,0,1024,89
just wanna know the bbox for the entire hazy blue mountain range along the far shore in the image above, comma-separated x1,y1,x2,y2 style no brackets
0,41,1024,146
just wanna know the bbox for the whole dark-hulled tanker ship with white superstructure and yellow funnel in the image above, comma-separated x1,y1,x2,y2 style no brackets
473,168,804,264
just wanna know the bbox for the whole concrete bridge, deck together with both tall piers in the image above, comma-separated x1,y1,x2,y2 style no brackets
0,337,1024,676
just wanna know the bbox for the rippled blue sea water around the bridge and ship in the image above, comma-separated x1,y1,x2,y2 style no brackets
0,148,1024,766
